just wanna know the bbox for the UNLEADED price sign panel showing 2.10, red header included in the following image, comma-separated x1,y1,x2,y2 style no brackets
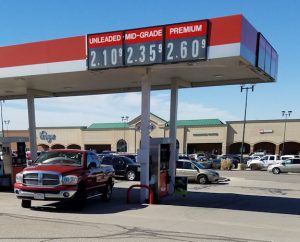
87,32,123,70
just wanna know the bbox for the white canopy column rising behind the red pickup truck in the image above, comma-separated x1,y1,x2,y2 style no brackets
27,91,37,164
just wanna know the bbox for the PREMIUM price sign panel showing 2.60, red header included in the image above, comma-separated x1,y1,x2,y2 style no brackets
164,20,208,63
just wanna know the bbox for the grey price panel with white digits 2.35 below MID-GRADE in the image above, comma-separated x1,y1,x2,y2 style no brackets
125,43,162,65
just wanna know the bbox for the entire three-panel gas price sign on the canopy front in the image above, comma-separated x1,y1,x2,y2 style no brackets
87,20,208,70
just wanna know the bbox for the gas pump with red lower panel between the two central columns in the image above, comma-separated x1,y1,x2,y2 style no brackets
149,138,170,202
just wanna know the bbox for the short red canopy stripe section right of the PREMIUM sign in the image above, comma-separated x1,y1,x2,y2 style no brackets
209,15,242,46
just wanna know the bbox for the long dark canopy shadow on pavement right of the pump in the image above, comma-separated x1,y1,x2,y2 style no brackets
161,192,300,215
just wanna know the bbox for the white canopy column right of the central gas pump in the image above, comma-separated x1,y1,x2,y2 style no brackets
169,80,178,194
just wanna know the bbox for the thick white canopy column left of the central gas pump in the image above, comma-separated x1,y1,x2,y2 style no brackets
139,76,151,203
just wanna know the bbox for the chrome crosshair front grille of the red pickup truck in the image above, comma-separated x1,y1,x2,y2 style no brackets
23,172,60,186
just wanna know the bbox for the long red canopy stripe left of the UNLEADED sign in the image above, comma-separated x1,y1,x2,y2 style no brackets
0,36,86,68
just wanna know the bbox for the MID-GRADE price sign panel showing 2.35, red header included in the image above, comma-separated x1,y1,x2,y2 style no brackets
124,26,163,66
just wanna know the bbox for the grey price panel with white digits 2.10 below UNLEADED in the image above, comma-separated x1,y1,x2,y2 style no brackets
89,47,123,68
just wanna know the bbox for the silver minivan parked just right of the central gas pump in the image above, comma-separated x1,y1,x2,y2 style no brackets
176,160,220,184
